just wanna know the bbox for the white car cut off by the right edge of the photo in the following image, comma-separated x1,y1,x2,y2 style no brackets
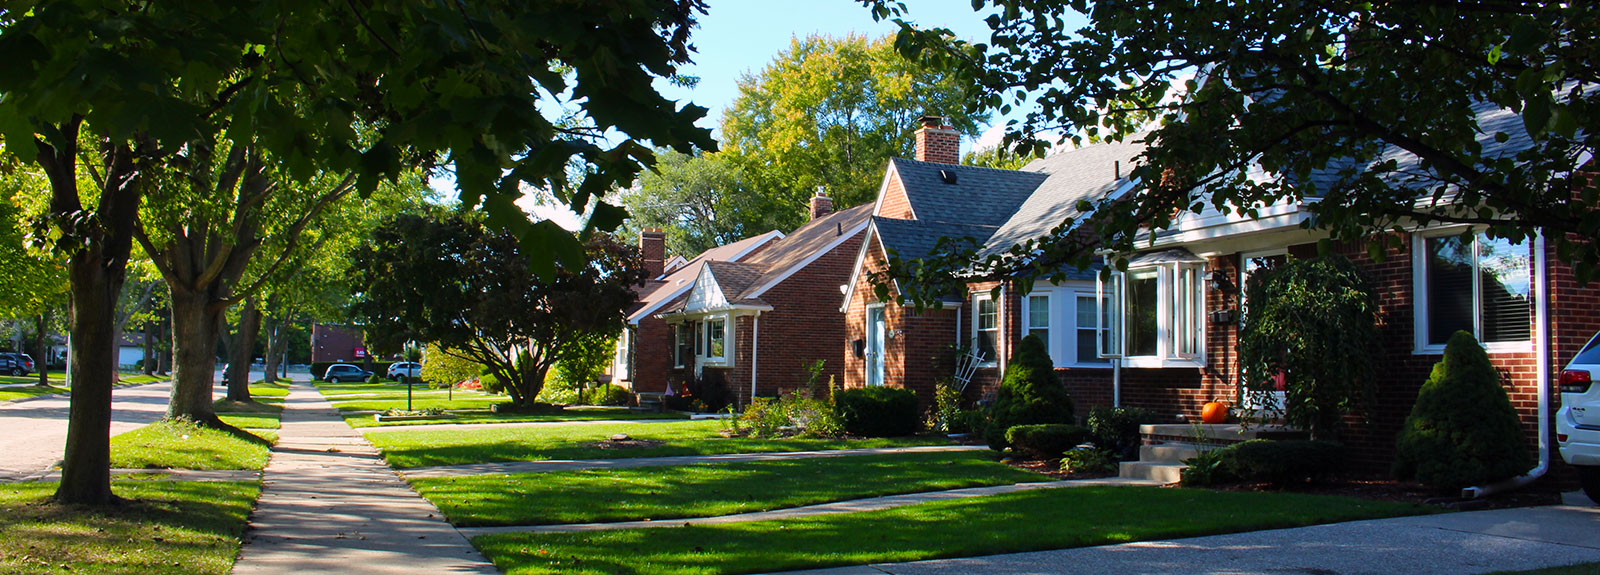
1555,333,1600,503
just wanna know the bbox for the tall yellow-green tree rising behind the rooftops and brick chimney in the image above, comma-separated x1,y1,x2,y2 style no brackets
722,35,989,229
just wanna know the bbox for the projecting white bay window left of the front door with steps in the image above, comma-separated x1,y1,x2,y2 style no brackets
1107,255,1205,367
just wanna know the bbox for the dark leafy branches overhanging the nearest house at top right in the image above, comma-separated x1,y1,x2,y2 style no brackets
862,0,1600,288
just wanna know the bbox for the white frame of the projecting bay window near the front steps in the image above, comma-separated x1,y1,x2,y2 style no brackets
1096,263,1206,367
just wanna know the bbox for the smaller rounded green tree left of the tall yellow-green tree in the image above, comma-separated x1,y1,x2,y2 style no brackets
621,151,761,258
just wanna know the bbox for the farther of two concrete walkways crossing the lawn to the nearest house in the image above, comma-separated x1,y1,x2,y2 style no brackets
400,445,989,479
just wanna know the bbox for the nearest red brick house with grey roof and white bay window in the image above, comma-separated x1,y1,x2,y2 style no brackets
842,107,1600,480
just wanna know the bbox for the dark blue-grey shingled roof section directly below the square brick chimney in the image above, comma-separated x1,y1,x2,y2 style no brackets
890,159,1048,226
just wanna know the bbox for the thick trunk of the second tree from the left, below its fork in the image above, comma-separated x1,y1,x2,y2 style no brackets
166,287,224,428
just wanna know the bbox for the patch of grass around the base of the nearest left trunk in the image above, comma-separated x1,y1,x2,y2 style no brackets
0,481,261,575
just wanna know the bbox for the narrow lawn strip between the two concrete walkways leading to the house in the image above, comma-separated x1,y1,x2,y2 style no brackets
411,453,1050,525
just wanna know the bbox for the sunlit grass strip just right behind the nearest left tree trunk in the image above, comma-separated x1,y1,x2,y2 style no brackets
110,420,278,471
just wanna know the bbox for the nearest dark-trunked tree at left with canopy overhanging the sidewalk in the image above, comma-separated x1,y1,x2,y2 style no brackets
0,0,714,505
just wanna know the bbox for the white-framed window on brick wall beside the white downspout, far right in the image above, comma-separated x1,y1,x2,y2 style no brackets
1413,234,1533,354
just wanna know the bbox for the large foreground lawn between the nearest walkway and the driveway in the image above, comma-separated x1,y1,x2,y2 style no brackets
472,485,1434,575
